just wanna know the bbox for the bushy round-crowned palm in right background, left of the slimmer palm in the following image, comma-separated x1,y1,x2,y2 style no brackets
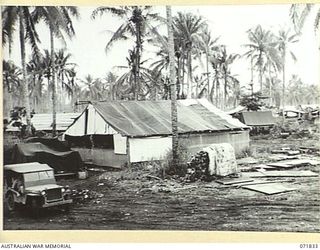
244,25,276,91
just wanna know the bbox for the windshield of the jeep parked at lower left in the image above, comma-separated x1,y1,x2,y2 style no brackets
23,170,56,187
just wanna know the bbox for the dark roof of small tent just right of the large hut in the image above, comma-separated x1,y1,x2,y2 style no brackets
241,111,276,126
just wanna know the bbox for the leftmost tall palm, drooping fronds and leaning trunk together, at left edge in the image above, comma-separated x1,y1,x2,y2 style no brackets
2,6,39,136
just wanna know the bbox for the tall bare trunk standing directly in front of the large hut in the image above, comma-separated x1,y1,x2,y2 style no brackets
166,6,179,166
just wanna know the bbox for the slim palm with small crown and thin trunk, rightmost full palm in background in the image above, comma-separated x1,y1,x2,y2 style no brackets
277,29,298,113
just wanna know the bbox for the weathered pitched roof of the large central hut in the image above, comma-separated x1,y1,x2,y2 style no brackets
93,99,248,137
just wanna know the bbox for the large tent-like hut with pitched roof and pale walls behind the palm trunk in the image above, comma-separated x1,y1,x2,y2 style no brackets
64,99,249,166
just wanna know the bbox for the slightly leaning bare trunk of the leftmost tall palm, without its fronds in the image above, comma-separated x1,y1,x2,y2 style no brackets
19,7,31,136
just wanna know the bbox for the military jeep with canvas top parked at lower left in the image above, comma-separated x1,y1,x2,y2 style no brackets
4,162,72,214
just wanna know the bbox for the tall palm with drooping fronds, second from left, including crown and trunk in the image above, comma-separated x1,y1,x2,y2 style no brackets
32,6,79,136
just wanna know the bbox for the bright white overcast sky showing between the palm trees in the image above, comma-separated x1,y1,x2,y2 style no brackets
4,5,320,92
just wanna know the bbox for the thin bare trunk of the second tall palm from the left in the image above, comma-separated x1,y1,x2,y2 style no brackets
50,27,57,137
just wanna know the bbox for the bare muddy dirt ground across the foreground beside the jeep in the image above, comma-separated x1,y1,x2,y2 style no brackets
4,139,320,232
